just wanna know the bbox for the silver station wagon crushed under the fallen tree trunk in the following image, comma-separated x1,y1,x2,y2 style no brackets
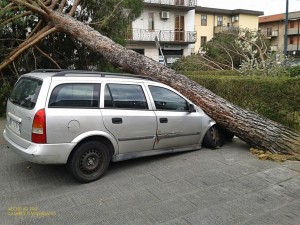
3,70,223,182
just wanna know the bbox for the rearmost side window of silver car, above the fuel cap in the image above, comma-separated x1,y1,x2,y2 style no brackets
49,84,100,108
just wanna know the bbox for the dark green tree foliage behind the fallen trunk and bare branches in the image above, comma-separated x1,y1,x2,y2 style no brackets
0,0,143,76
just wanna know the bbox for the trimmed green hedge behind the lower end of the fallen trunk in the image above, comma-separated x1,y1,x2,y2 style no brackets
188,72,300,130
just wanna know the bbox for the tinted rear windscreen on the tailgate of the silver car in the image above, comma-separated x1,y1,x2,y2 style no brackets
9,77,43,109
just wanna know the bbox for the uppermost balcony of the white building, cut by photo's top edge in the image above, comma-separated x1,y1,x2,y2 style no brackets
144,0,196,10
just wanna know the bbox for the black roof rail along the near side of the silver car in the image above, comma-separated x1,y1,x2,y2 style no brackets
52,70,158,81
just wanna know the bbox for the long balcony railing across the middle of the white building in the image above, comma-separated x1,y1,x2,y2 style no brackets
127,29,197,43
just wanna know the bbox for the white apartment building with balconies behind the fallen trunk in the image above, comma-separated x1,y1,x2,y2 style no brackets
127,0,197,64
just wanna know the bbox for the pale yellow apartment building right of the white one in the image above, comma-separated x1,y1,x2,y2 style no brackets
195,6,264,52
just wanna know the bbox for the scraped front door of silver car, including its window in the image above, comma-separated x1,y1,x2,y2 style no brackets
148,85,202,149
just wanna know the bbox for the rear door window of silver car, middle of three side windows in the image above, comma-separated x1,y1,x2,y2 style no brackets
104,84,148,109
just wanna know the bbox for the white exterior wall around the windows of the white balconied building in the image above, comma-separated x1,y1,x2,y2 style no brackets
127,5,196,62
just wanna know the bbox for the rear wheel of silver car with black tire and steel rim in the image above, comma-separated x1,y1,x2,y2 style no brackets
67,141,110,183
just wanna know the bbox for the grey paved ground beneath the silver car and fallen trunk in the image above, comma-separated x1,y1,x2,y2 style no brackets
0,116,300,225
